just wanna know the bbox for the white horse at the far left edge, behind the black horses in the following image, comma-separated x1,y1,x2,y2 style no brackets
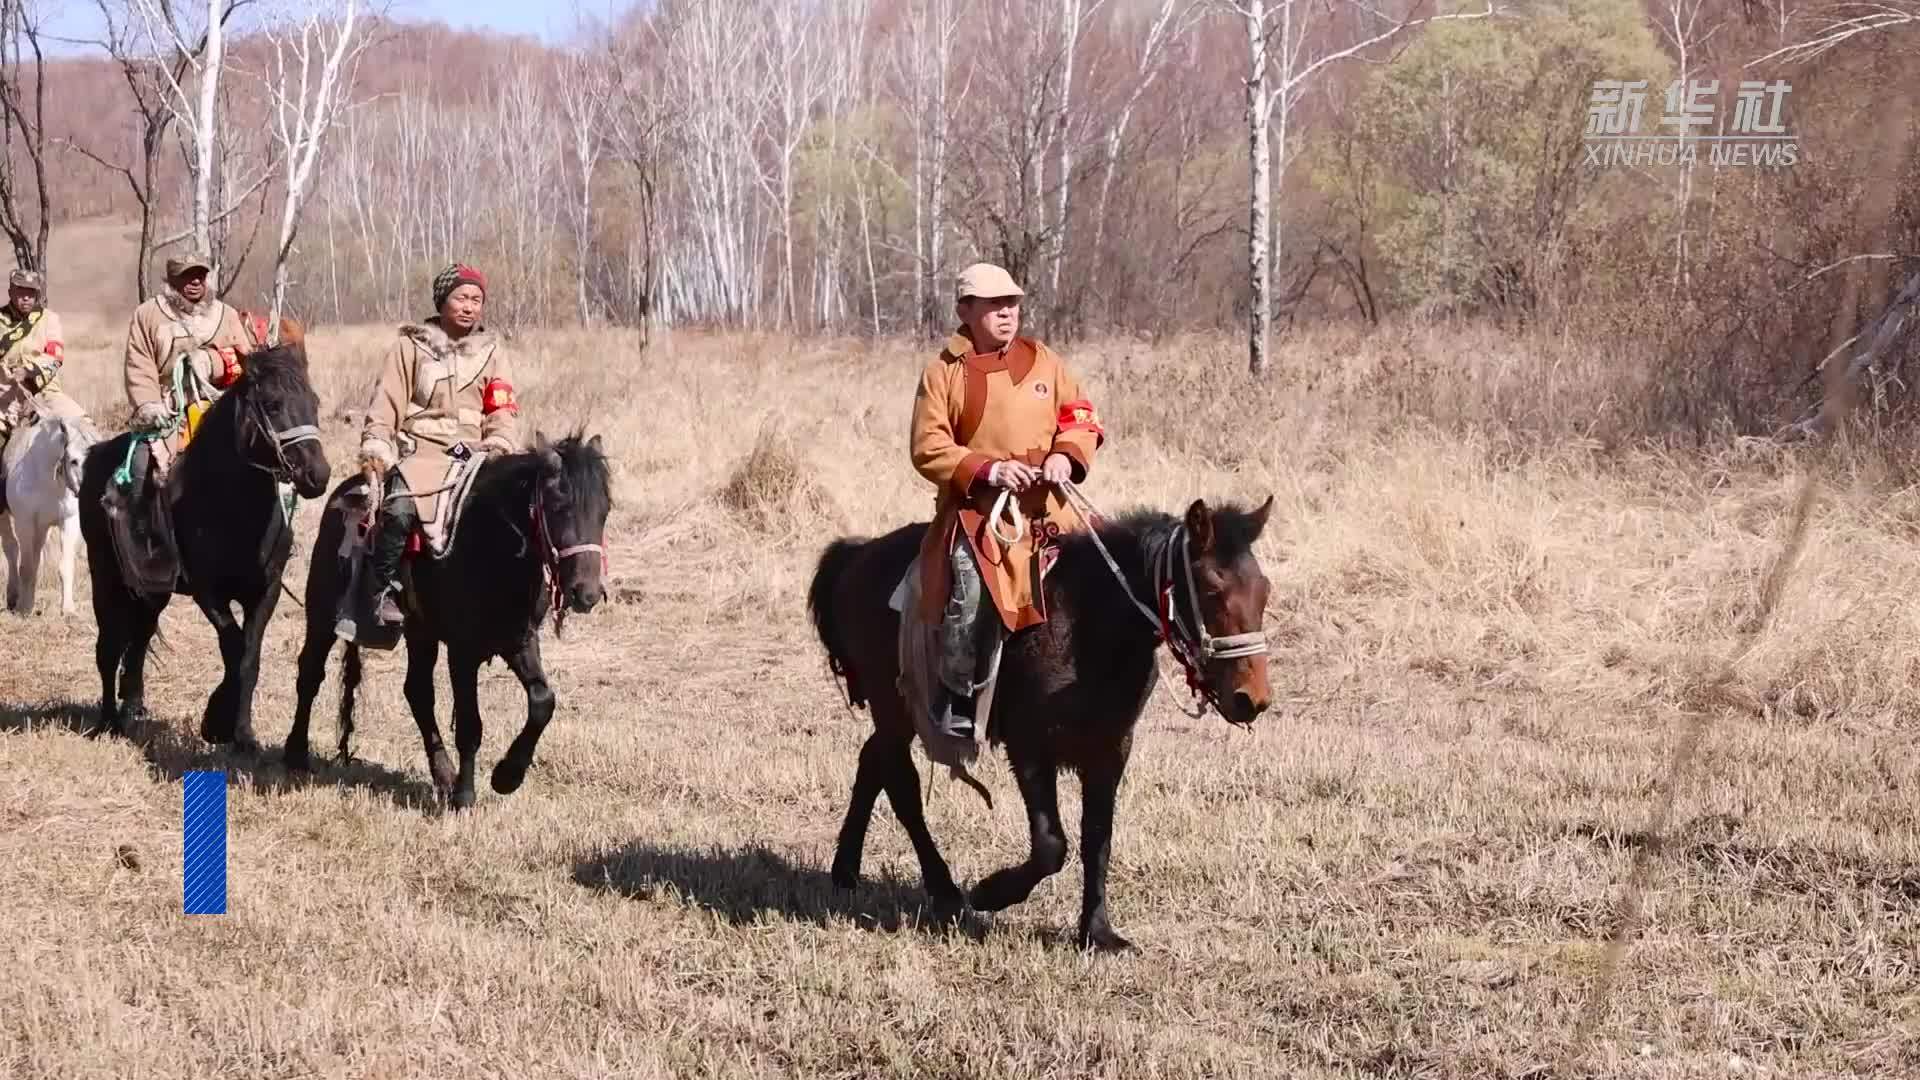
0,415,100,615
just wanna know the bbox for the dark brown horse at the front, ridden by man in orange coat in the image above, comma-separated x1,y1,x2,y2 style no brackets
806,492,1273,949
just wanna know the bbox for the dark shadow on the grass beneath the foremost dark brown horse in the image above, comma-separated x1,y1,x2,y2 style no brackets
574,840,983,940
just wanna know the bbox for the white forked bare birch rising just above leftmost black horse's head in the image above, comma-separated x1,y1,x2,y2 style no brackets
267,0,371,334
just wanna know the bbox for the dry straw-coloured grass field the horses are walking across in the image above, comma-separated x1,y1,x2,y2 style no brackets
0,305,1920,1080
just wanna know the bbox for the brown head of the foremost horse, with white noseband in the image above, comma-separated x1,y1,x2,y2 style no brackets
1158,496,1273,724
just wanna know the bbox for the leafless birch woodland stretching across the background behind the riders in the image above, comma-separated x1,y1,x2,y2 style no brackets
0,0,1920,427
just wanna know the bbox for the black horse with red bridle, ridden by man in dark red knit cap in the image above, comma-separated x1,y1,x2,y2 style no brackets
286,424,612,809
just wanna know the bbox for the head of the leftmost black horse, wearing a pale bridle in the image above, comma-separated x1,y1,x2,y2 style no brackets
221,336,332,500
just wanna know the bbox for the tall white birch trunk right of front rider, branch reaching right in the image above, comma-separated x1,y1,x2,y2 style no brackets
1219,0,1494,375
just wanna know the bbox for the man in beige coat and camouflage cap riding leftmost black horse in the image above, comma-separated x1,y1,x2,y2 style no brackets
125,252,280,519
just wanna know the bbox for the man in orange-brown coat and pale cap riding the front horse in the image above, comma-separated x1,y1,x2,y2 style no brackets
912,263,1106,738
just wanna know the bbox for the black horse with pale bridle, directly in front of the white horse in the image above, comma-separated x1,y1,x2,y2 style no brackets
79,336,330,749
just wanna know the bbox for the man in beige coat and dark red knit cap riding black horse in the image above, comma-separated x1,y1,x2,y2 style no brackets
338,263,520,648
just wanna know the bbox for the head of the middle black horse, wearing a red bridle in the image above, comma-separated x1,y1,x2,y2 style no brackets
534,432,612,613
